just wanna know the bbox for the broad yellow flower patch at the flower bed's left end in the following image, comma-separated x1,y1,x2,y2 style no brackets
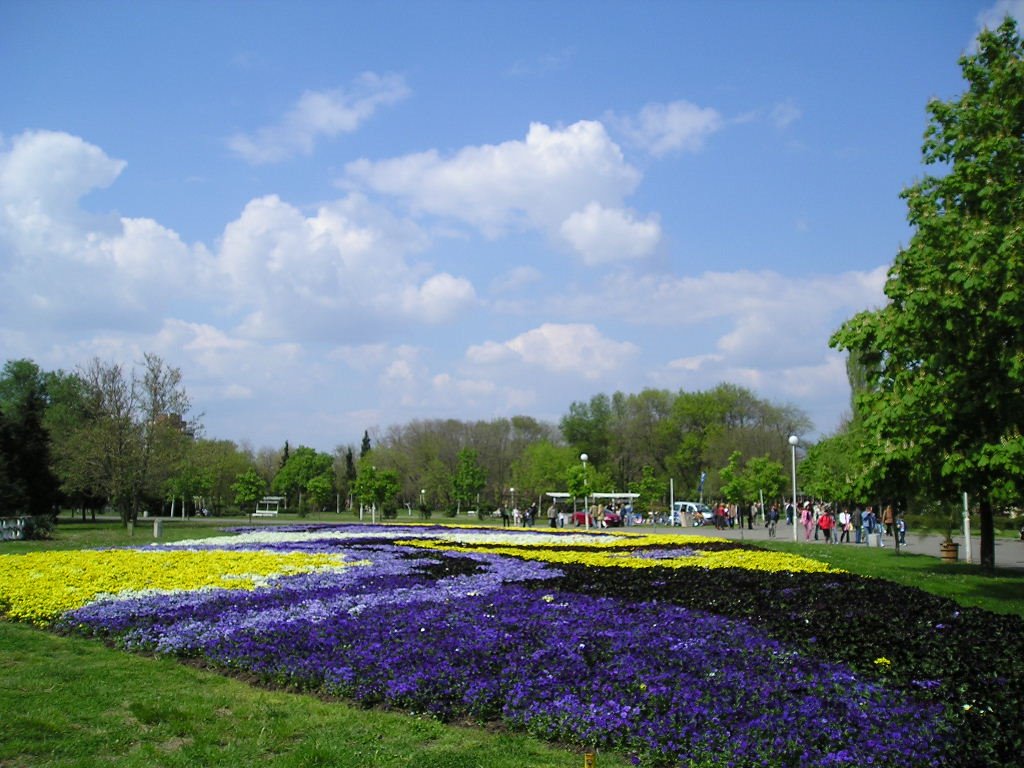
0,549,365,625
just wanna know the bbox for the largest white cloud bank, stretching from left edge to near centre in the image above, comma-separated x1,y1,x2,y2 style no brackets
0,131,476,352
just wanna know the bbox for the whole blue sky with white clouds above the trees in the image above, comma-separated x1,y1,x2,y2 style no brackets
0,0,1024,451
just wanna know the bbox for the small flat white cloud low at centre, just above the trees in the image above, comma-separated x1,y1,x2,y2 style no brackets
466,323,640,379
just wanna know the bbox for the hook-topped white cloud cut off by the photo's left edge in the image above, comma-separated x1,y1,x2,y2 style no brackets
0,131,209,328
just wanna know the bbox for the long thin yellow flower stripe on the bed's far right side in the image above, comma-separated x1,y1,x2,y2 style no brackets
396,537,840,573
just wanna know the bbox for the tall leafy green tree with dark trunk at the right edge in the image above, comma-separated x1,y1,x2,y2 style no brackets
831,18,1024,567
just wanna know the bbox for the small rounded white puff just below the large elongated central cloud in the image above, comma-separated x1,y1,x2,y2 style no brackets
560,203,662,266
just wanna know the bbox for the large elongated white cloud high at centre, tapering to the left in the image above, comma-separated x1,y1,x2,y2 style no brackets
342,121,640,238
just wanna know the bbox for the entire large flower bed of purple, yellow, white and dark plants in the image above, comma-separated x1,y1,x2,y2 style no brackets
0,525,1024,766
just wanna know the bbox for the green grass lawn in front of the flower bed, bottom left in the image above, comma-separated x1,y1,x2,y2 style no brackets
0,622,627,768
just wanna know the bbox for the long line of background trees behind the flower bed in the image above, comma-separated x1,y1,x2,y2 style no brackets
0,354,810,523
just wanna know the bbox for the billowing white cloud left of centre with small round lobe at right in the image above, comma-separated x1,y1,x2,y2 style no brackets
218,195,475,339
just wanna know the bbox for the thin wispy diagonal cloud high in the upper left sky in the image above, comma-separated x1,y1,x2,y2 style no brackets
227,72,410,165
